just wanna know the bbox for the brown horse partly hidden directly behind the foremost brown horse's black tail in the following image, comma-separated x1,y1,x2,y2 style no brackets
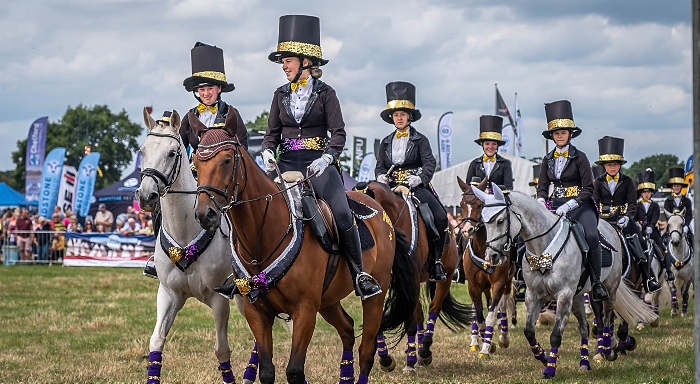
355,181,472,372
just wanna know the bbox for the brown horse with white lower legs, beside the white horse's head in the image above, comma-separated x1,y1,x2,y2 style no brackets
457,177,515,357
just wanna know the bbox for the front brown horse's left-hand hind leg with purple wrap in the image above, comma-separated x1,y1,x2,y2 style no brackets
319,303,355,384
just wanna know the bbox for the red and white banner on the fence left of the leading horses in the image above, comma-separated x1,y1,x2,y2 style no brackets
63,232,156,268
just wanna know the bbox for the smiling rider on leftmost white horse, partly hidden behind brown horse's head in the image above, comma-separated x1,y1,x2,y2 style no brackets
180,42,248,152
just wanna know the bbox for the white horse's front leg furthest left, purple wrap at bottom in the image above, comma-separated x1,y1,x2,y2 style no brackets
146,284,186,384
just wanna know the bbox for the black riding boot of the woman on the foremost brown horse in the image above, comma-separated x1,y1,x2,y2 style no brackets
339,224,382,300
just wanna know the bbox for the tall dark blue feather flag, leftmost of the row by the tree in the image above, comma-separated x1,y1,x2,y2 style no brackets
24,116,49,204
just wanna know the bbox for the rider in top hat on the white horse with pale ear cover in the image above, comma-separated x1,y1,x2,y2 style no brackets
537,100,609,301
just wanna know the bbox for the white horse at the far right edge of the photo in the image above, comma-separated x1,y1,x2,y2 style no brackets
664,212,695,317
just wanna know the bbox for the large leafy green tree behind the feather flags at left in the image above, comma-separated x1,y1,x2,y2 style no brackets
12,104,143,189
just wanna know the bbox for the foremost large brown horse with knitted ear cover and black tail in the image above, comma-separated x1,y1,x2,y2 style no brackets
192,110,418,384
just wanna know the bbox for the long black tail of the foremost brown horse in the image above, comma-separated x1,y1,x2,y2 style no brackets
379,229,419,339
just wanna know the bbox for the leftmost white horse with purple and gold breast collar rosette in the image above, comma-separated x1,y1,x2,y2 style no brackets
136,109,257,384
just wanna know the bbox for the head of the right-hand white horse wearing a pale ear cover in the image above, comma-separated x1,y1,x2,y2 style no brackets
472,184,520,266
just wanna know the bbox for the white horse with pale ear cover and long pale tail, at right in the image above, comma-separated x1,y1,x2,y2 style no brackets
474,186,657,379
